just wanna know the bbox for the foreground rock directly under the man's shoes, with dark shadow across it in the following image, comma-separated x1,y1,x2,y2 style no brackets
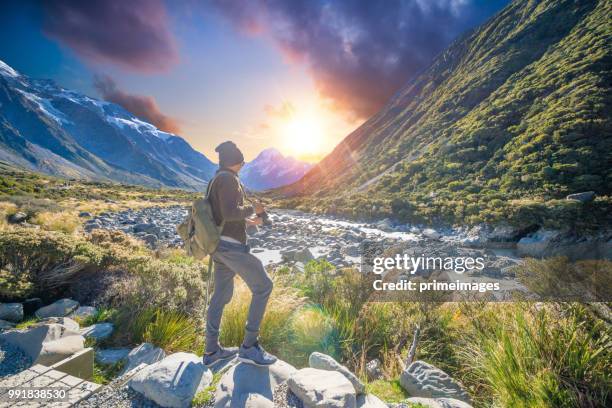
215,360,296,408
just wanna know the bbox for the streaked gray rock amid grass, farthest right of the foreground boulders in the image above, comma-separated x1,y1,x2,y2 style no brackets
400,361,470,402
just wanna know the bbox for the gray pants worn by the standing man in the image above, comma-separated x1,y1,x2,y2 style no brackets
206,241,272,353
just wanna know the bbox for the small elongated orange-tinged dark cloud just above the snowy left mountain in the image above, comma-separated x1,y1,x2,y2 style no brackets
94,75,180,133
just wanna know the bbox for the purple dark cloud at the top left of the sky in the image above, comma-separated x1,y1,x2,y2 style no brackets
43,0,178,72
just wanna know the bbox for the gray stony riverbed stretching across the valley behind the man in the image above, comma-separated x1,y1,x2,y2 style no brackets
80,206,520,292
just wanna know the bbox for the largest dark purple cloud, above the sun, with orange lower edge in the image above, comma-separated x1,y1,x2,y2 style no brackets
211,0,508,117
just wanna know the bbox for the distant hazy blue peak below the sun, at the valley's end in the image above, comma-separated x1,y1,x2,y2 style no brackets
240,148,312,191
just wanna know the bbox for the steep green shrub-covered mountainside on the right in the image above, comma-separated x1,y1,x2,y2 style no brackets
279,0,612,230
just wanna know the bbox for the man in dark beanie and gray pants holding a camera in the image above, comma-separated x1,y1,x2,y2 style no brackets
204,141,276,365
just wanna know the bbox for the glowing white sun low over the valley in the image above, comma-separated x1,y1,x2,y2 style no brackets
282,115,325,158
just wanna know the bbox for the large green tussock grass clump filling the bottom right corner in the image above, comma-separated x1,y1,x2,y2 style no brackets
458,304,612,407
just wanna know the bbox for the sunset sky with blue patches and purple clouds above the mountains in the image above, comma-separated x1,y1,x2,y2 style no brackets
0,0,508,162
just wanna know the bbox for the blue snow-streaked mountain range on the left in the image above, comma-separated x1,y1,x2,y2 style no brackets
0,61,217,189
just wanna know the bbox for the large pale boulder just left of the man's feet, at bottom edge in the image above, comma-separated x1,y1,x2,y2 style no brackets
130,353,213,408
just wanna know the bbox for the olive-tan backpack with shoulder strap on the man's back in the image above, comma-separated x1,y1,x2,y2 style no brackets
176,170,232,259
